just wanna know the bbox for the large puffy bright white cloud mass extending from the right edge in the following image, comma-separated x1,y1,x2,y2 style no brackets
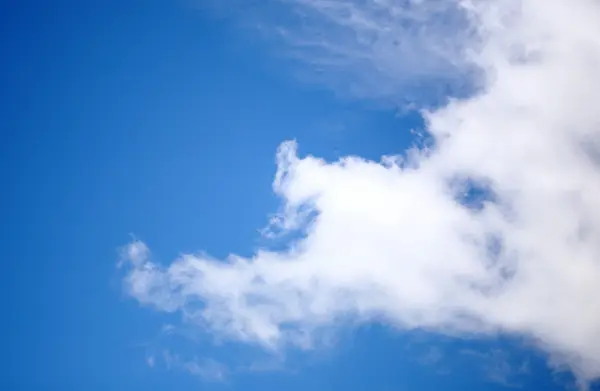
119,0,600,380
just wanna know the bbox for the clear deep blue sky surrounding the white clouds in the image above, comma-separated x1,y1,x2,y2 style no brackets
0,0,600,391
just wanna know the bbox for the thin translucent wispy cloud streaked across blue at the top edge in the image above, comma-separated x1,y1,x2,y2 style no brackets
272,0,478,106
